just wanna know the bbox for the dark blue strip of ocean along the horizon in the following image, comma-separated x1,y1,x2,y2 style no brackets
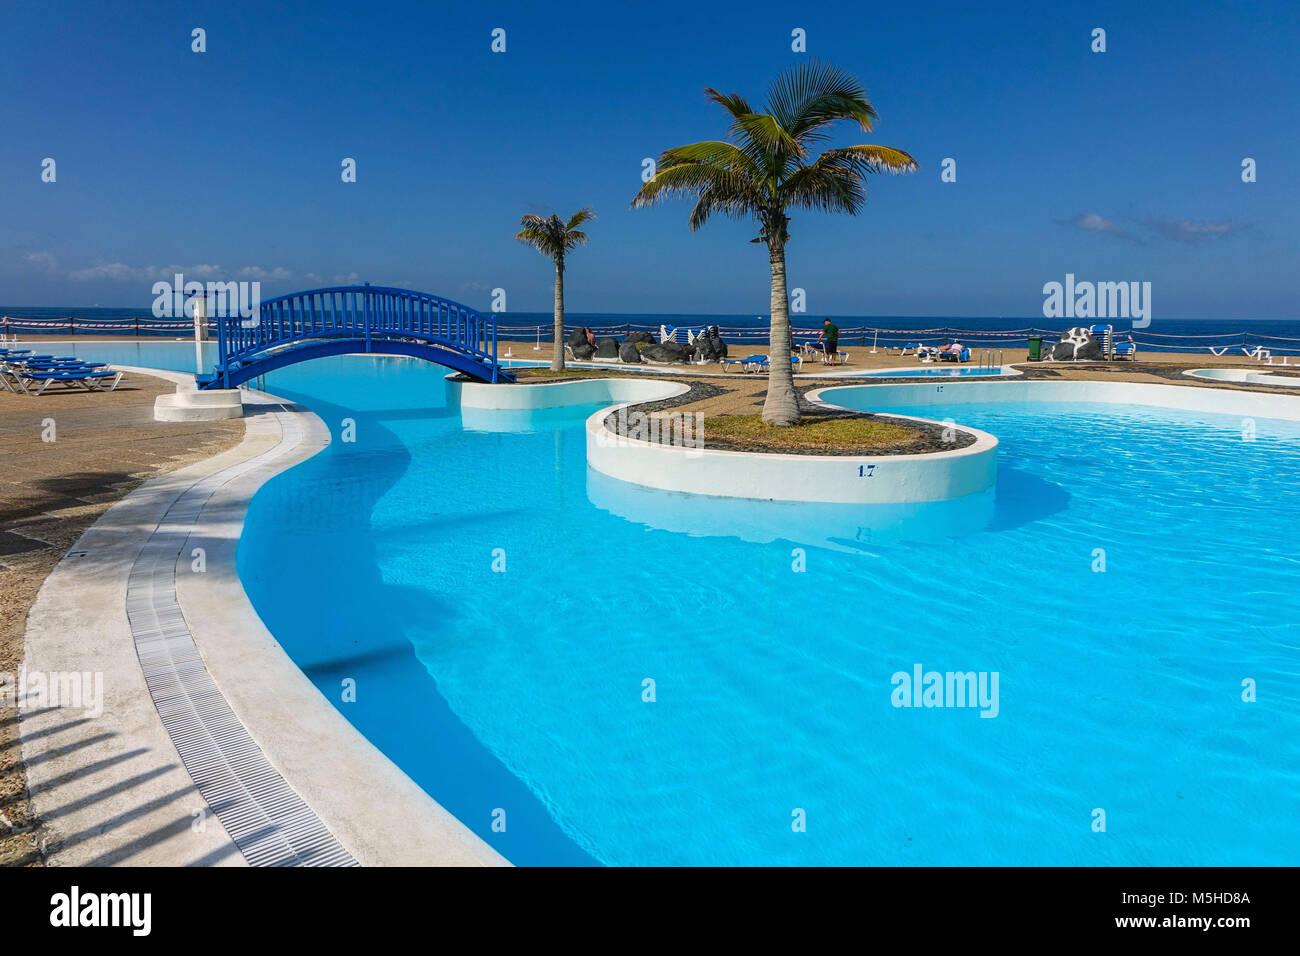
0,306,1300,354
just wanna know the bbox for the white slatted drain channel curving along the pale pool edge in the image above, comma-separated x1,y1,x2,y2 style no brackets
126,403,358,866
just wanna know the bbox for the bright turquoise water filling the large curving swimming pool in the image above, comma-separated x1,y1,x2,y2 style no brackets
61,345,1300,865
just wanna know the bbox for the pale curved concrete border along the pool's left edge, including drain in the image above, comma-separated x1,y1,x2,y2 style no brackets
20,372,507,865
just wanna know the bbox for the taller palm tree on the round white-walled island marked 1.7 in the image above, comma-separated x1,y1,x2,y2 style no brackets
632,62,917,425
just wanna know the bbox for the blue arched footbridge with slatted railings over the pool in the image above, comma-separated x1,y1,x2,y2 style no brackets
198,284,515,389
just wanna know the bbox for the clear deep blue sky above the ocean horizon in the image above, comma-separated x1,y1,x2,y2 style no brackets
0,0,1300,319
